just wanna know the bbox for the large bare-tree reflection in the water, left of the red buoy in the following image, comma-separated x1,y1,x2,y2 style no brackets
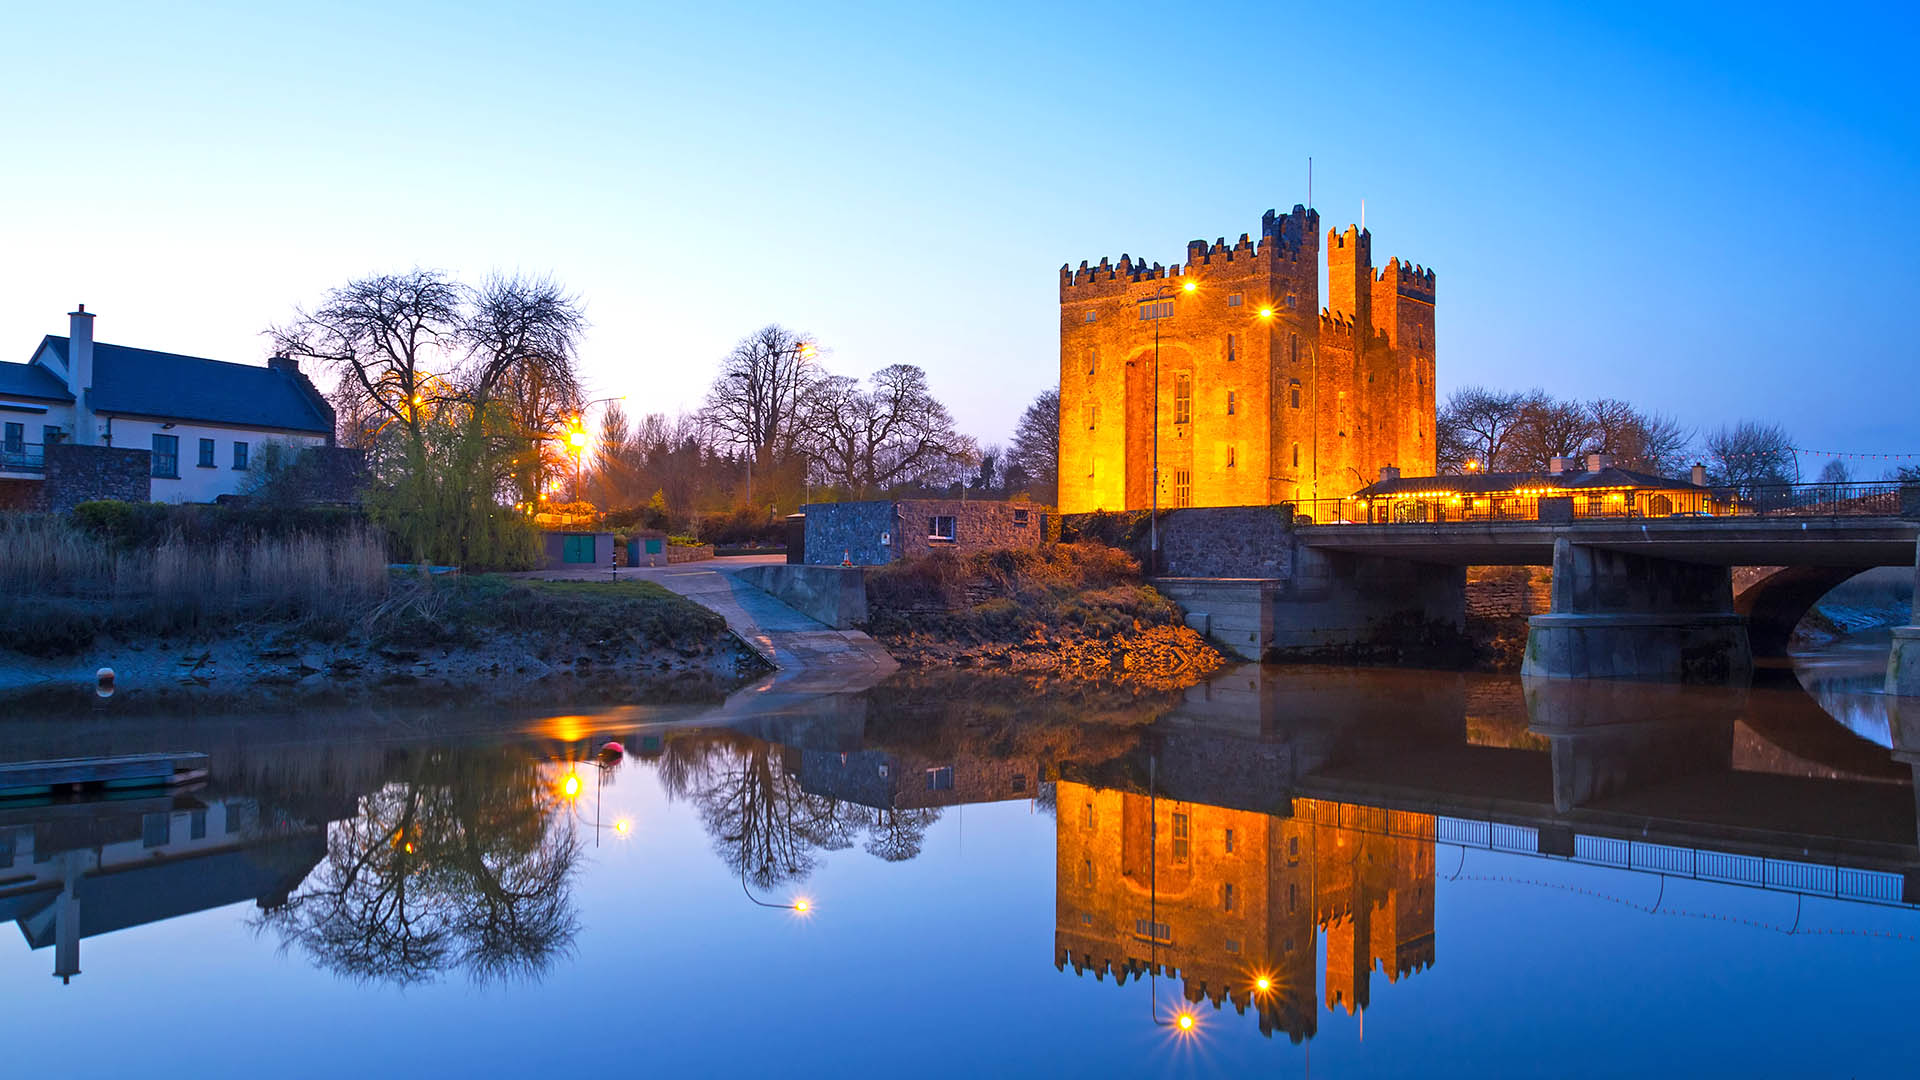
255,748,580,986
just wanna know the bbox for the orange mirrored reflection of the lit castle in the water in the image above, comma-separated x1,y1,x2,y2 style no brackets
1054,780,1434,1042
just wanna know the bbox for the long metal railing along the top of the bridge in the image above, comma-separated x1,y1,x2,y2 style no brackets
1294,480,1920,525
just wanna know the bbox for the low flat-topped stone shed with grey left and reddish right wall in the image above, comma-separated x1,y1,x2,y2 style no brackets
801,500,1050,567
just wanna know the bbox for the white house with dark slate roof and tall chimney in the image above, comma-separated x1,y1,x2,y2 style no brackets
0,304,334,505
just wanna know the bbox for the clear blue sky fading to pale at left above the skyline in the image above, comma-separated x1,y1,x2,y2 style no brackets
0,4,1920,473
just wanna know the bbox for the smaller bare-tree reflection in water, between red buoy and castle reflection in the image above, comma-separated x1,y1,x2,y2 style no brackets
660,732,939,890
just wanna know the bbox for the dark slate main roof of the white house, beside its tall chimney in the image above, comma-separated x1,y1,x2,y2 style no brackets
42,334,334,434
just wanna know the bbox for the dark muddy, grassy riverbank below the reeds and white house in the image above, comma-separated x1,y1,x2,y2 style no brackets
0,575,766,701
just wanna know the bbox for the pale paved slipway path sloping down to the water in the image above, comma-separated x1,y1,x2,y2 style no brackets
520,555,900,692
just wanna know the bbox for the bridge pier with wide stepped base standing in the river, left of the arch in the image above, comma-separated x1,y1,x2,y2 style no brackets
1521,536,1753,682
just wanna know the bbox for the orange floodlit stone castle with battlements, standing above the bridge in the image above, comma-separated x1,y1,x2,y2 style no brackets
1060,206,1434,513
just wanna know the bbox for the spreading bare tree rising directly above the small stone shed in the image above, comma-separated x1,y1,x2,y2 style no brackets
803,363,977,496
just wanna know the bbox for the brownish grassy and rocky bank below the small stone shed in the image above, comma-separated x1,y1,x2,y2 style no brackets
866,544,1221,684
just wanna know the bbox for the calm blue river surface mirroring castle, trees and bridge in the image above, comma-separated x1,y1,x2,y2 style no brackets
0,651,1920,1076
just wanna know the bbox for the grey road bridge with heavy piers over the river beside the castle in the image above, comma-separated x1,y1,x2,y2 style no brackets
1164,509,1920,680
